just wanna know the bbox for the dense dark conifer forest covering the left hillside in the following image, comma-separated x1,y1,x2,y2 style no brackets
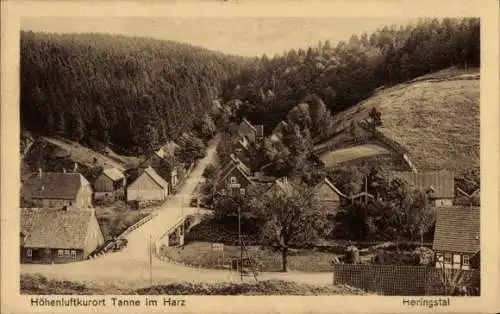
21,32,251,153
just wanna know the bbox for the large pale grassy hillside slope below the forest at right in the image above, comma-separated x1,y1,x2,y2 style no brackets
323,68,480,173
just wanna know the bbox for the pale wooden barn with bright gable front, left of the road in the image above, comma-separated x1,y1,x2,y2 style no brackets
127,167,169,202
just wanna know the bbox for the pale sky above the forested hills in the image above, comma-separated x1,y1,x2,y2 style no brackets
21,17,415,56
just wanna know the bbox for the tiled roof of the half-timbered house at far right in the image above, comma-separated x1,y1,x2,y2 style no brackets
432,206,481,253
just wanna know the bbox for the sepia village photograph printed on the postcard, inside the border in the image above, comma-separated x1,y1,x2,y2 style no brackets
2,1,498,311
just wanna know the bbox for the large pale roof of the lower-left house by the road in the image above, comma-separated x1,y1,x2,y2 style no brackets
21,209,96,249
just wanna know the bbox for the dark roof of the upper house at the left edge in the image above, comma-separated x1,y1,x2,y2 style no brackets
22,172,89,200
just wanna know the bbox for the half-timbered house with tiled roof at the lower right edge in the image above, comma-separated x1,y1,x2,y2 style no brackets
432,206,481,269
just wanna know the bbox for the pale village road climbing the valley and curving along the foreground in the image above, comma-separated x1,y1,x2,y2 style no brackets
21,136,332,288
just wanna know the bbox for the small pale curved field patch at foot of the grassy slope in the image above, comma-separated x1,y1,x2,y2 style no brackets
319,144,391,168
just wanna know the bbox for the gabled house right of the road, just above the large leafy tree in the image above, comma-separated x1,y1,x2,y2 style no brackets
214,155,254,196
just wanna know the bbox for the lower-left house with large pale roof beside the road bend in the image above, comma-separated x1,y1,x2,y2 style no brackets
20,207,104,263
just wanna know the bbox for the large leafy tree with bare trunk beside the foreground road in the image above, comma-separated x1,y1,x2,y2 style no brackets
249,185,324,271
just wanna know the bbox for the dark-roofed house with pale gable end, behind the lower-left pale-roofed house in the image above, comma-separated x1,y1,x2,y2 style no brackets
21,169,93,208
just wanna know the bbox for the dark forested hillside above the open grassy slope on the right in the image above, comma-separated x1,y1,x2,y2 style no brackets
224,18,480,139
